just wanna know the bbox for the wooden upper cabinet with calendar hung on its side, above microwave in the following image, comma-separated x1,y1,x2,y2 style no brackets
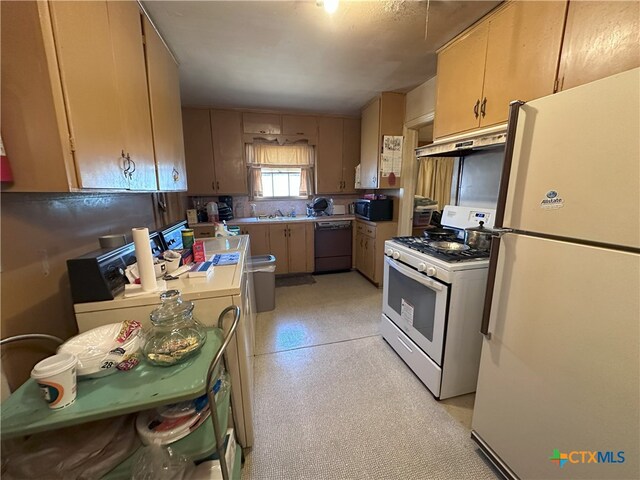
359,92,405,188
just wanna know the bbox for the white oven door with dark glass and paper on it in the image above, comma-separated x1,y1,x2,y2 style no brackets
383,258,449,365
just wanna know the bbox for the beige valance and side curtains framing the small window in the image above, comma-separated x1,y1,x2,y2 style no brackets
245,142,315,198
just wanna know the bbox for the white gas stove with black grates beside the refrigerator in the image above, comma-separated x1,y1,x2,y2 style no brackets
381,206,495,399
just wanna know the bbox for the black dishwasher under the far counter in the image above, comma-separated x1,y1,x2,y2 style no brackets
314,220,351,273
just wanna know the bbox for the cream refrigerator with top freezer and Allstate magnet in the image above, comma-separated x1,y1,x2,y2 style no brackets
471,69,640,479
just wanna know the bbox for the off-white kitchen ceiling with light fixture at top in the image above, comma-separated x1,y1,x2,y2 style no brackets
143,0,500,114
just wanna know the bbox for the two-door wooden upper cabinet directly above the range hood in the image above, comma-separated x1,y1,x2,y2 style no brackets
434,1,567,138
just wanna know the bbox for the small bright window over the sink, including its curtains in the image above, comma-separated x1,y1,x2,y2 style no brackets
245,142,315,199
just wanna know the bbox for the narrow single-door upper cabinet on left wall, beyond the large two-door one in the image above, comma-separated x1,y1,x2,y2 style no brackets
144,15,187,191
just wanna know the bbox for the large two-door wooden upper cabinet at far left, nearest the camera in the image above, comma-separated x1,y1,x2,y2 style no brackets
0,2,156,192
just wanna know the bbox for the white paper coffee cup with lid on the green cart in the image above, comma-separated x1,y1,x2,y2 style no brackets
31,353,78,410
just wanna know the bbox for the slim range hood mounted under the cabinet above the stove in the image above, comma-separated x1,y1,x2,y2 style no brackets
416,123,507,158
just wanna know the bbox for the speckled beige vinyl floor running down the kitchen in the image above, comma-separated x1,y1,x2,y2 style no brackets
242,272,498,480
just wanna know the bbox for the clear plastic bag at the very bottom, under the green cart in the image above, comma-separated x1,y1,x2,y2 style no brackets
131,443,195,480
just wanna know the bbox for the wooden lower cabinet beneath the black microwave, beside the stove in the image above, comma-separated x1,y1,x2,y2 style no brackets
355,220,398,286
